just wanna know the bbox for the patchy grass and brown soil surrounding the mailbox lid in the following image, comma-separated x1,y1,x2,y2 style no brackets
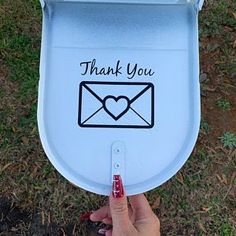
0,0,236,236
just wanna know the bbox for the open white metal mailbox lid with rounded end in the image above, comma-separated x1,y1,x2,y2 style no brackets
38,1,200,195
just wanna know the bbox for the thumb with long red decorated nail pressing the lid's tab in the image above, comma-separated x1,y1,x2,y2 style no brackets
109,175,131,229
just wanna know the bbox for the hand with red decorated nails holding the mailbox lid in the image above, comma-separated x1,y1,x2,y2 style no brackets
90,175,160,236
